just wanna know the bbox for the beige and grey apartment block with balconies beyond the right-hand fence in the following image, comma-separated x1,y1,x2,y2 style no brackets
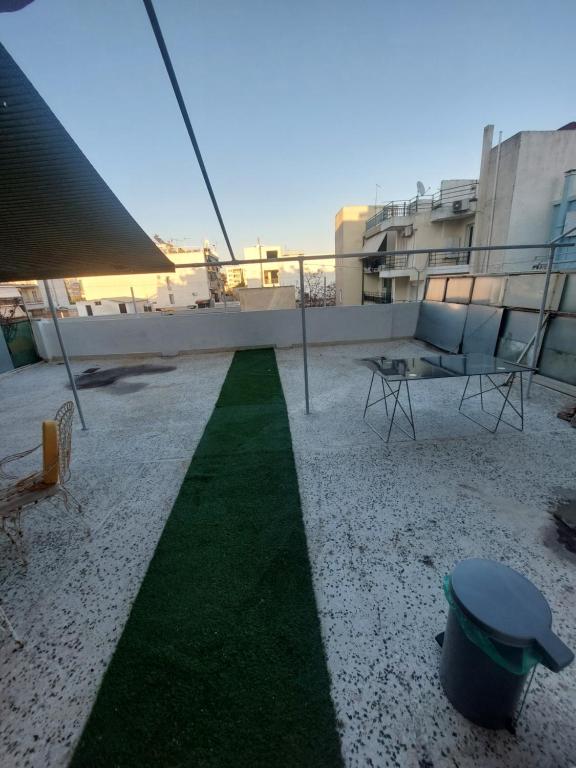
335,123,576,304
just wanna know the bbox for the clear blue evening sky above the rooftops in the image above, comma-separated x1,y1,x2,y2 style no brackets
0,0,576,257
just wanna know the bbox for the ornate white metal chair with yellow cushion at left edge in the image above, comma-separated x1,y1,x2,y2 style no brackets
0,401,90,565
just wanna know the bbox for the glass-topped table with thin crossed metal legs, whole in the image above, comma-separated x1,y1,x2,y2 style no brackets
357,352,535,443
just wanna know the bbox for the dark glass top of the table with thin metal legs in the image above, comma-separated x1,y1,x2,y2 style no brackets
357,352,534,381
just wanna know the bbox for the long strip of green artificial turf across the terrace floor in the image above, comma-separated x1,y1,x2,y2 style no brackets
71,349,342,768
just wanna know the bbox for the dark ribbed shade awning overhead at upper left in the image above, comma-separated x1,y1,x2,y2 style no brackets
0,45,174,282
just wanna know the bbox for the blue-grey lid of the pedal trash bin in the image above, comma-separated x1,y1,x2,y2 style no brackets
451,559,574,671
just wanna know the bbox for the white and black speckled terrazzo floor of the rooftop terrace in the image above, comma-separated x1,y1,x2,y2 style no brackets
0,340,576,768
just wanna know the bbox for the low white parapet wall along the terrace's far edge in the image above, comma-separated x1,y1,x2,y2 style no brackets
33,302,419,360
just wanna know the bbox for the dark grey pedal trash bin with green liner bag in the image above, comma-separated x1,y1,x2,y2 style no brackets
440,559,574,728
